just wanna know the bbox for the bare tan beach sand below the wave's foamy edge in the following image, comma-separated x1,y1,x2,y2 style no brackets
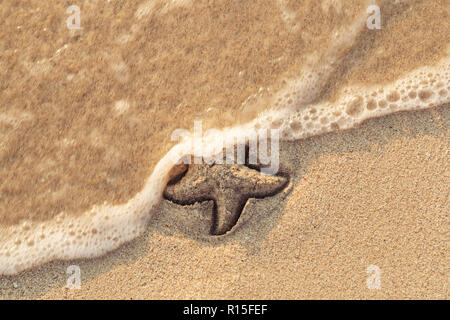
0,105,450,299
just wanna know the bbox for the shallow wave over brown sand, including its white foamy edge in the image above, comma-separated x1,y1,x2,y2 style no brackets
0,0,450,274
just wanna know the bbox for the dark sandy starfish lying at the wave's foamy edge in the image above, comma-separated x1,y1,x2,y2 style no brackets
164,163,288,235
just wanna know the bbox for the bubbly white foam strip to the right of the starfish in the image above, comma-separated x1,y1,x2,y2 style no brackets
258,59,450,140
